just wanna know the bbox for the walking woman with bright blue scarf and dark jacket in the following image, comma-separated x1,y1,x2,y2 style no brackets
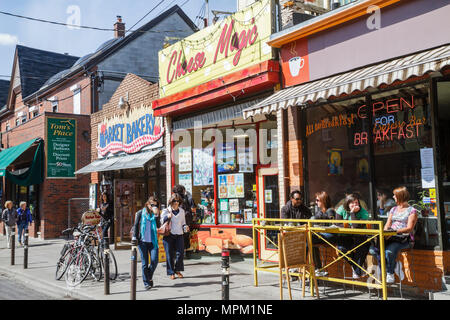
132,196,161,290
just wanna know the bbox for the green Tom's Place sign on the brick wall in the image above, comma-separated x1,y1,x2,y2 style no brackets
46,118,77,178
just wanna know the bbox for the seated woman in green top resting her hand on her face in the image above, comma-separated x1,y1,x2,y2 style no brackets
336,193,370,279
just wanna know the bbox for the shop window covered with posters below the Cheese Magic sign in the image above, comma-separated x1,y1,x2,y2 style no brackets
174,121,277,225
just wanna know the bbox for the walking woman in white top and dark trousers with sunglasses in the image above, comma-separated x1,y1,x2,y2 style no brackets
161,193,189,280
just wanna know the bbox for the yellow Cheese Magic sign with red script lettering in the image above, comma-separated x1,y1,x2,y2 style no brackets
159,0,275,97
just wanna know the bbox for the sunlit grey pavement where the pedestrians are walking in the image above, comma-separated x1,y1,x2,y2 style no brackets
0,235,417,301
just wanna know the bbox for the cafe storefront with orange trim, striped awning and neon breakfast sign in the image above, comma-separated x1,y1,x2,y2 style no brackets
243,0,450,292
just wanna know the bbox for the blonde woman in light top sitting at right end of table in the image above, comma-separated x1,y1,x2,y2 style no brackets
370,187,418,283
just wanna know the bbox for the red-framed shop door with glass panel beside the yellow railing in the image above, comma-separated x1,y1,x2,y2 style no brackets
258,168,280,261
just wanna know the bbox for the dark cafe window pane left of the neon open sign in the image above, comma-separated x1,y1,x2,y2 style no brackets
305,97,373,216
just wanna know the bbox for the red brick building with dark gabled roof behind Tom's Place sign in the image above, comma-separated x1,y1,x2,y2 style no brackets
0,5,197,238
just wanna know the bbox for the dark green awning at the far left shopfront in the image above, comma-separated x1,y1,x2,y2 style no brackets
0,138,44,186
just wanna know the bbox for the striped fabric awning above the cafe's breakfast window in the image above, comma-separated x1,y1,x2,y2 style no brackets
243,45,450,119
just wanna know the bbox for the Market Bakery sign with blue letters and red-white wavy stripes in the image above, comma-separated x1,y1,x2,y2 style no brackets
97,105,164,158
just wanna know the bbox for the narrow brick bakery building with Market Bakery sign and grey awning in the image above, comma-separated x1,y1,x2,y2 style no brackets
76,74,163,248
